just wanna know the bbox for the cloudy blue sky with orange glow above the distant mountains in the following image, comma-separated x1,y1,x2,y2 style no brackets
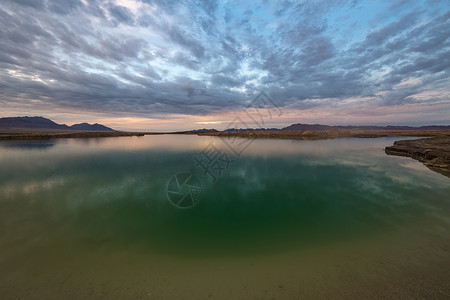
0,0,450,131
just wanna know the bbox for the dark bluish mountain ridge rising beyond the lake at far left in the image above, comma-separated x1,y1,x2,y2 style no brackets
0,117,114,131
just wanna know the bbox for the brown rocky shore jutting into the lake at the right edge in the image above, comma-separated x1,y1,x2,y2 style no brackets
385,136,450,177
